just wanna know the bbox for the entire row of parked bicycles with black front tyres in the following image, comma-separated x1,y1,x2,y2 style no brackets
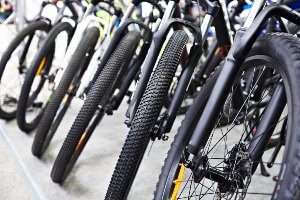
0,0,300,200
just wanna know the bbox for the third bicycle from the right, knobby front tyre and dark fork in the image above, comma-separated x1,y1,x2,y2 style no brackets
51,0,163,183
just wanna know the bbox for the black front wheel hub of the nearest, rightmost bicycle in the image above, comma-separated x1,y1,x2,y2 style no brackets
190,144,252,199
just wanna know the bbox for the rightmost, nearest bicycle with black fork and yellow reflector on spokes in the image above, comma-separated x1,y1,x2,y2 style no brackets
154,0,300,199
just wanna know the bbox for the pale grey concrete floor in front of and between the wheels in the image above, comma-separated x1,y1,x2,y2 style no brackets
0,99,183,199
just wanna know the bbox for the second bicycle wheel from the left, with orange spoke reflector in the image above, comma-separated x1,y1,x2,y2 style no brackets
17,22,73,132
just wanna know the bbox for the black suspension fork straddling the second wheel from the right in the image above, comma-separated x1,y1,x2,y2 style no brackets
126,1,219,126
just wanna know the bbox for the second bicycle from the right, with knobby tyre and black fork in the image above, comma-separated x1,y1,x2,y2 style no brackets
101,1,241,199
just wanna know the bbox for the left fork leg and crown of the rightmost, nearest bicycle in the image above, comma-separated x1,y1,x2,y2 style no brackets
188,2,300,155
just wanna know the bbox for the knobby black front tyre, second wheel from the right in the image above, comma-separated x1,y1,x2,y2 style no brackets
105,30,188,199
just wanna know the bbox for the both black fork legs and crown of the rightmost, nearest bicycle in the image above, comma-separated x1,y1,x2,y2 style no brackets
188,5,300,172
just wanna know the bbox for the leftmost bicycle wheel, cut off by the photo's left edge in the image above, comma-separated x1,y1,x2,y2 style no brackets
0,21,51,120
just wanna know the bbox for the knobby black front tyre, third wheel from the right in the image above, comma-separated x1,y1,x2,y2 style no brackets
51,31,140,183
